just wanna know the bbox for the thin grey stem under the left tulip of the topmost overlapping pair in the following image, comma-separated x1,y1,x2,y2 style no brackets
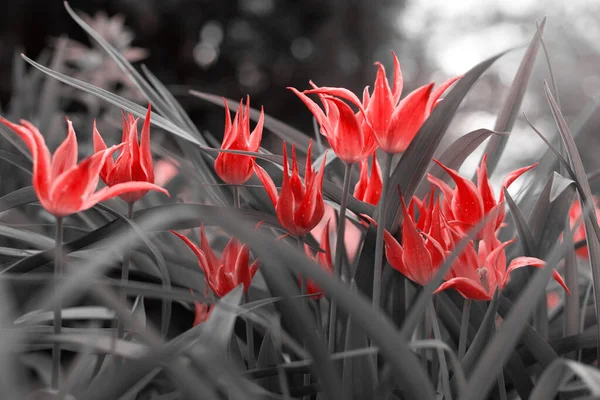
327,163,352,354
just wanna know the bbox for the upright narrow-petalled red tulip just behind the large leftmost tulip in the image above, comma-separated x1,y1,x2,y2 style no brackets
94,104,168,203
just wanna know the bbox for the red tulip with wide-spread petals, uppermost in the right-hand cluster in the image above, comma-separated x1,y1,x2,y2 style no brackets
427,155,537,233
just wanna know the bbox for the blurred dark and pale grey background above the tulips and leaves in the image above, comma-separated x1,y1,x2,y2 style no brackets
0,0,600,178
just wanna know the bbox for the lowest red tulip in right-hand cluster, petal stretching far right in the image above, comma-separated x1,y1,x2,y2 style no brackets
436,212,570,300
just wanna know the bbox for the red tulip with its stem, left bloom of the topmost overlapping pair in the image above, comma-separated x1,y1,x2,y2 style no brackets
290,82,377,353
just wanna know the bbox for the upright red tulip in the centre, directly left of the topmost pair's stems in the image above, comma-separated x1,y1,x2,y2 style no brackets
254,141,327,236
